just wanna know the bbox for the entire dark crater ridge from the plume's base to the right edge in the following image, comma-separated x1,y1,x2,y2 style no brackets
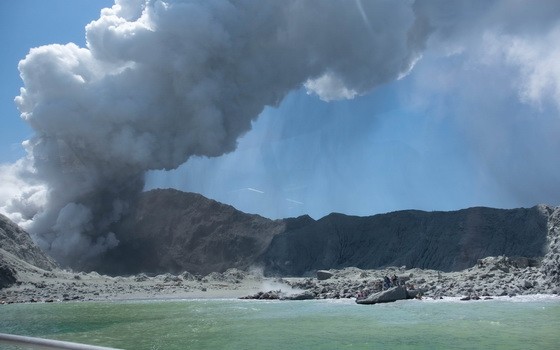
93,190,554,276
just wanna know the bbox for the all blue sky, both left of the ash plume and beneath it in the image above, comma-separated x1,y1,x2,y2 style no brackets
0,0,560,227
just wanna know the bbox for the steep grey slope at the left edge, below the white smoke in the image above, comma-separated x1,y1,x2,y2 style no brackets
0,214,58,270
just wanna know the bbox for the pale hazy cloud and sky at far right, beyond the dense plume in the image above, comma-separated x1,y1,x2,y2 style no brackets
402,1,560,206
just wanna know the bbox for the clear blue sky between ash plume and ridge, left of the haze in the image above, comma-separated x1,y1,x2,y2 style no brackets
149,81,484,217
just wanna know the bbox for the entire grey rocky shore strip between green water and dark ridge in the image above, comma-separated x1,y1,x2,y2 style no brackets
0,253,560,304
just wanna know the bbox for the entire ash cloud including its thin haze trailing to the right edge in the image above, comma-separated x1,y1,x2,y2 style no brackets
4,0,560,266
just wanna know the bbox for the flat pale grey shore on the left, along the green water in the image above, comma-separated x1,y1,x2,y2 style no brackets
0,269,262,304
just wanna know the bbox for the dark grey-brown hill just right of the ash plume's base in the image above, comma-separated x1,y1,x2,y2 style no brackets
97,189,286,275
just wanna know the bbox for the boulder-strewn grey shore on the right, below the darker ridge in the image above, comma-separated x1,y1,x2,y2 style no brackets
240,257,560,299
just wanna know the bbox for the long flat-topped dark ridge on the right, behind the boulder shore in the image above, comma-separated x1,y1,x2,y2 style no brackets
263,206,557,276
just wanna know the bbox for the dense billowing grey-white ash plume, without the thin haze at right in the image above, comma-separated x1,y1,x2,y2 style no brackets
3,0,427,265
